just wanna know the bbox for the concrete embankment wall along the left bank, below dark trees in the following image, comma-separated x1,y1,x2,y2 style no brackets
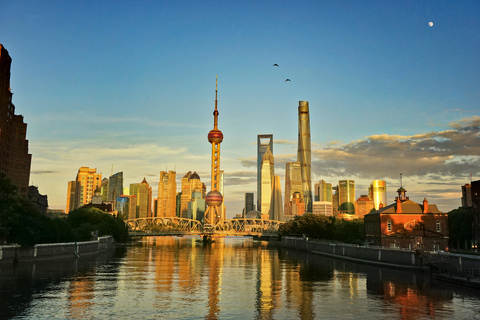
0,236,114,263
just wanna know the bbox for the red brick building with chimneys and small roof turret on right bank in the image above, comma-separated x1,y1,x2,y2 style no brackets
364,188,448,251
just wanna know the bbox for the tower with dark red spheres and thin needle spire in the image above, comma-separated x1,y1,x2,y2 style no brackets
205,79,223,225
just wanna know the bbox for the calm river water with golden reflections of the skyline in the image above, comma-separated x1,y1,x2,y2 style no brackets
0,237,480,319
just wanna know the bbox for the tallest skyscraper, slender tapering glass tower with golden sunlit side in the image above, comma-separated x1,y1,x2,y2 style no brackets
297,101,312,212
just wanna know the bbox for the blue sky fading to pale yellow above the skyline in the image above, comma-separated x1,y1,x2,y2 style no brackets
0,0,480,218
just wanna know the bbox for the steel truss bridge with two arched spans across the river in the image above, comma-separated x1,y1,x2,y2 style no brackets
125,217,284,237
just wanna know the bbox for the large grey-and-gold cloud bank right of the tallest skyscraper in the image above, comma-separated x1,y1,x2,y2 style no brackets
312,117,480,178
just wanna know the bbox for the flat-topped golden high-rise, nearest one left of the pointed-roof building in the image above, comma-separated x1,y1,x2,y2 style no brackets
157,171,177,217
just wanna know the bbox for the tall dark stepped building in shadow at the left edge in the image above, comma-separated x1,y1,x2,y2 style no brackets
0,44,32,197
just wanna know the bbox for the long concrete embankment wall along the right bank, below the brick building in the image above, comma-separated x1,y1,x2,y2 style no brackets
282,237,426,269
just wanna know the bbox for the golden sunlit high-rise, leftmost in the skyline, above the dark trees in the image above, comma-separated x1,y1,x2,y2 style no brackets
67,167,102,213
